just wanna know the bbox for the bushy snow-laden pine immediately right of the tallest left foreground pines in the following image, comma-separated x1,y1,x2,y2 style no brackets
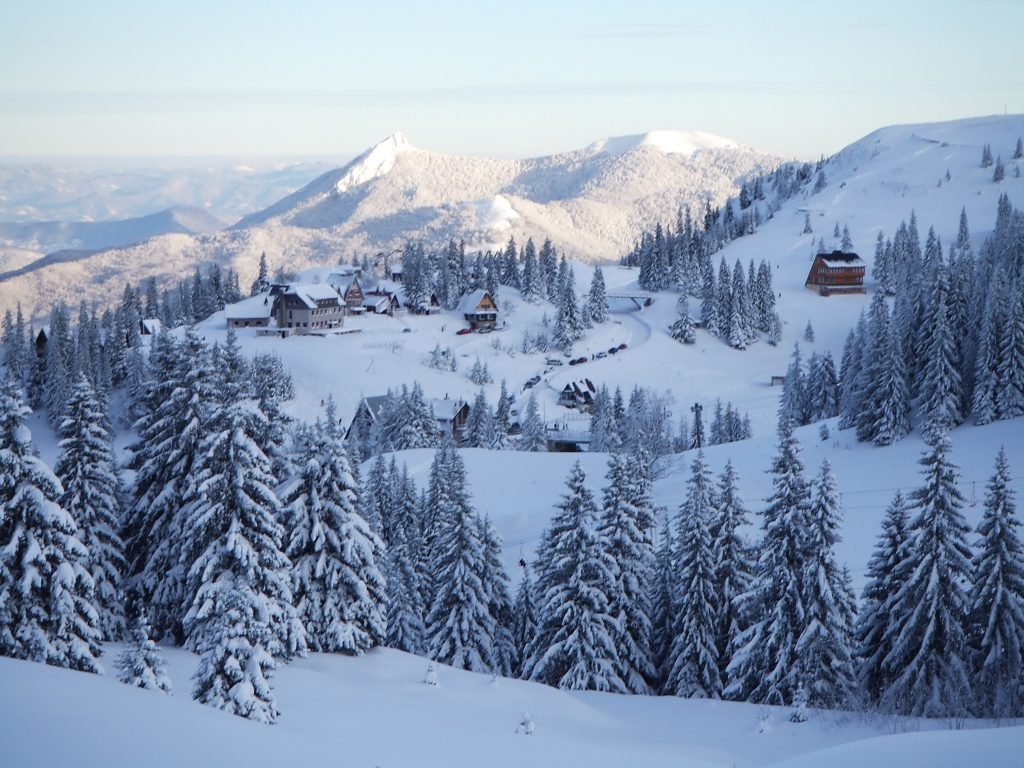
282,421,387,655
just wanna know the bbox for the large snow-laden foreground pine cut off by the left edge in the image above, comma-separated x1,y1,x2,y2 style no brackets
0,378,101,672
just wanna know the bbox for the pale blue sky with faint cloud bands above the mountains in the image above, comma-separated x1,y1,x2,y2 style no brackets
0,0,1024,159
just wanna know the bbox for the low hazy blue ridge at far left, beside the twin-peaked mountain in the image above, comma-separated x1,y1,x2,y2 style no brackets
0,206,227,253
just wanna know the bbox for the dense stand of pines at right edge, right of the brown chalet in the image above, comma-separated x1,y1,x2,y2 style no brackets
840,195,1024,445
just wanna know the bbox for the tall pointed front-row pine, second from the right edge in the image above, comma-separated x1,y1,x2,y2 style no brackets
882,424,971,717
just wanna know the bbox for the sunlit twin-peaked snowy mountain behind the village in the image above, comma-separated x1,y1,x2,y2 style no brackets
239,131,777,261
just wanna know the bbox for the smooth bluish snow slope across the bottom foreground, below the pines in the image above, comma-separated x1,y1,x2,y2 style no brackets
0,646,1024,768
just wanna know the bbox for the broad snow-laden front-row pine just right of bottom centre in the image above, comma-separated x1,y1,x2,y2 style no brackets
523,462,627,693
